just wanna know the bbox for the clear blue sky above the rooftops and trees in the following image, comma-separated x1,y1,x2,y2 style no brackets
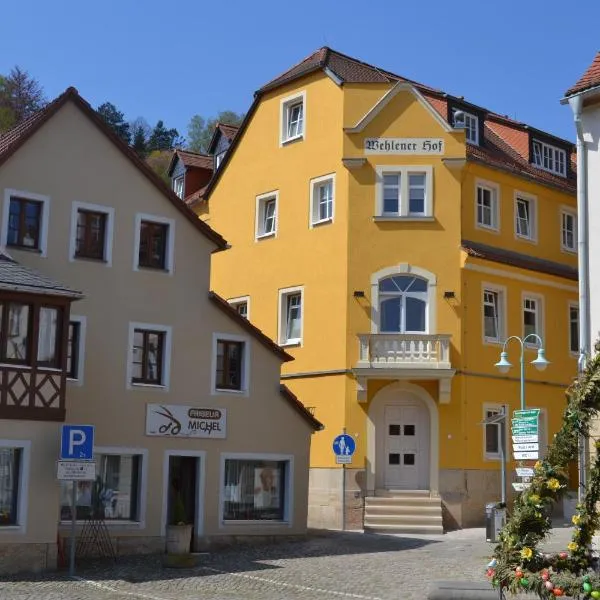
0,0,600,139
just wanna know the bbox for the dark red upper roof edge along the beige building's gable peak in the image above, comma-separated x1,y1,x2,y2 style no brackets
0,87,227,250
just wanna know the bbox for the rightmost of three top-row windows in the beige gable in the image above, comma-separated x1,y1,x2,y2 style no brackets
133,213,175,273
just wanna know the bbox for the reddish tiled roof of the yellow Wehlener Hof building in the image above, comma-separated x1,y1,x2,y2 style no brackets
206,47,576,199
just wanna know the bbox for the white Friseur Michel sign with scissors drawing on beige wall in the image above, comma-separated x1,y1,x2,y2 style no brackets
146,404,227,438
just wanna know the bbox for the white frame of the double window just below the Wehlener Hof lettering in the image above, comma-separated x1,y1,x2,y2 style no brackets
375,165,434,221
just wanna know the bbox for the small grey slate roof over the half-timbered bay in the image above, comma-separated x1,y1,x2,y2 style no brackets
0,251,83,300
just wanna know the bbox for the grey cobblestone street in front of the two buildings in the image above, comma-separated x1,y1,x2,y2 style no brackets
0,528,570,600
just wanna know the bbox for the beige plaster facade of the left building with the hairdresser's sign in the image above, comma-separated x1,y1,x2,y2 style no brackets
0,91,316,573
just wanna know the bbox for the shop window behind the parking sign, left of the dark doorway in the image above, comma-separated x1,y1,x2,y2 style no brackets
60,453,142,521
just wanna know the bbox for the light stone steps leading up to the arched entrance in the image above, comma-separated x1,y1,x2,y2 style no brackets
363,490,444,534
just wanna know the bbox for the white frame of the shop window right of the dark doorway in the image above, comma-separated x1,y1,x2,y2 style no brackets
219,452,295,529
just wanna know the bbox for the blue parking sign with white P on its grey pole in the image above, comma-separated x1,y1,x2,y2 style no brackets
57,425,96,577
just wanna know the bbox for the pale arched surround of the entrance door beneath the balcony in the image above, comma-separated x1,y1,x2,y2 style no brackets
367,381,439,496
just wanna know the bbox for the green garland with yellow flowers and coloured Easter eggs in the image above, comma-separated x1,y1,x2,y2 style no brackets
487,346,600,599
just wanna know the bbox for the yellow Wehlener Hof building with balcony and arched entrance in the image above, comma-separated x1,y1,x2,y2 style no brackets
194,48,578,531
